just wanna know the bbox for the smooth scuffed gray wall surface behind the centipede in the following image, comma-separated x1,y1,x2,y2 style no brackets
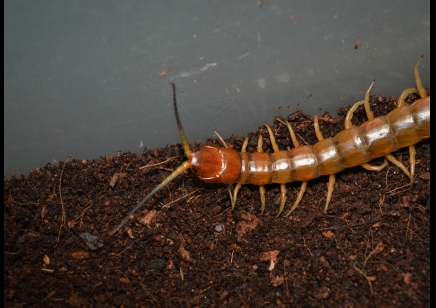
4,0,430,176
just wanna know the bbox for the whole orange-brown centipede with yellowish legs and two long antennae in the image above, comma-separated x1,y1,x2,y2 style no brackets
109,56,430,235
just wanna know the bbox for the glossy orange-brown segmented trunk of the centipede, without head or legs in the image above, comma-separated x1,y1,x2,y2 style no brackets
228,97,430,185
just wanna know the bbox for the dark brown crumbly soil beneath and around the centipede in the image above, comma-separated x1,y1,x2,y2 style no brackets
4,92,430,307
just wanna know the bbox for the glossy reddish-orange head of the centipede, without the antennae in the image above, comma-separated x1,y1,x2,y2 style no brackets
189,145,242,184
